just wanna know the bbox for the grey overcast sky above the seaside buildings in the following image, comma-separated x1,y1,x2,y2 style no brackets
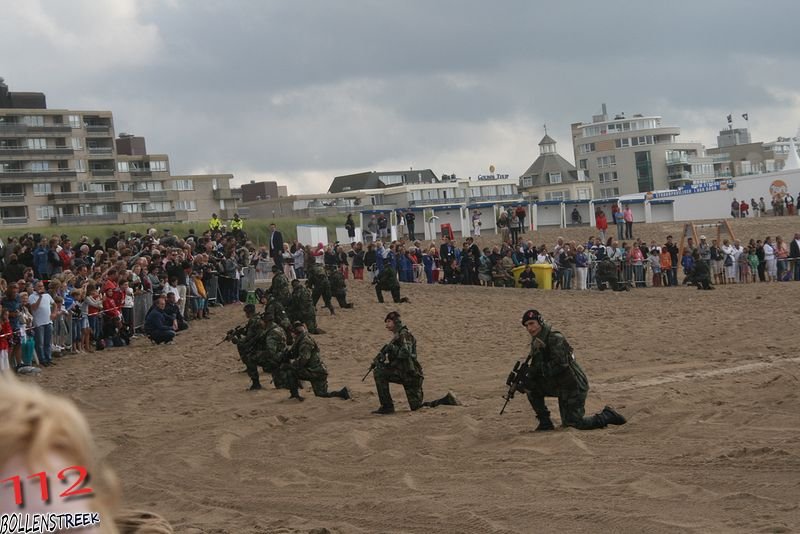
0,0,800,194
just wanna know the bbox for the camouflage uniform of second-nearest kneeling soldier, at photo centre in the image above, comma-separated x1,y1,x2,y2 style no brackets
373,322,424,411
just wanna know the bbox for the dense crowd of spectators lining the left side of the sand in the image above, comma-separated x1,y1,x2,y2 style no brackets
0,229,258,373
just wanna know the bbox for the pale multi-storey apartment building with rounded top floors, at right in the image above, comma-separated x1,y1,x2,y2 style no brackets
572,104,714,198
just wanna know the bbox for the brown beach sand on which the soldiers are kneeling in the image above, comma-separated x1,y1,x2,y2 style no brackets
34,218,800,534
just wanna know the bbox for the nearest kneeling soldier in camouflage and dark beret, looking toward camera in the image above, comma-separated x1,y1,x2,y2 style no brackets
522,310,626,431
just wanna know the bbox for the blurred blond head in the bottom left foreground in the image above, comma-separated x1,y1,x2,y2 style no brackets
0,374,172,534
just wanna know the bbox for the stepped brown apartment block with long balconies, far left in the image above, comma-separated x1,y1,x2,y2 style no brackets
0,78,234,227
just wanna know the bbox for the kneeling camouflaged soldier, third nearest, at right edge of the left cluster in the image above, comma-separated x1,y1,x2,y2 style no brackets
281,321,350,401
